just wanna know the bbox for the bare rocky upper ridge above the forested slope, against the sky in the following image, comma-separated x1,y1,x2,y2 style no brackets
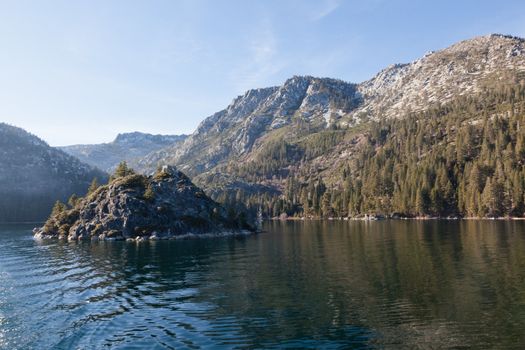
132,34,525,175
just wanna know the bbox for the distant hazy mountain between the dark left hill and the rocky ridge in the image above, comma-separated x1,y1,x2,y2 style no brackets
60,132,186,172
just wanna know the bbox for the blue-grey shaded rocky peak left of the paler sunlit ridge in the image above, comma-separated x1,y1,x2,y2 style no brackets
132,76,361,175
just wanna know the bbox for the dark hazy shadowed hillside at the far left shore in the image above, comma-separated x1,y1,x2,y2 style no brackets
0,123,107,222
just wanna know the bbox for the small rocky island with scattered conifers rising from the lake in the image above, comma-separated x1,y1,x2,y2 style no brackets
34,163,255,241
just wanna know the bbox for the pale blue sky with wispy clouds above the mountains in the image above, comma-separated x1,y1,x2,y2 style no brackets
0,0,525,146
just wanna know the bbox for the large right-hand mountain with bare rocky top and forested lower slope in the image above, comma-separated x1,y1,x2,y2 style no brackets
132,34,525,216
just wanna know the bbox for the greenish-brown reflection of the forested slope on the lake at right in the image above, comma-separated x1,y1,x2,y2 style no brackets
194,221,525,346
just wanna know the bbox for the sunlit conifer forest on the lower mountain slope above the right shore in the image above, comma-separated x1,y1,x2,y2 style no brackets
209,84,525,217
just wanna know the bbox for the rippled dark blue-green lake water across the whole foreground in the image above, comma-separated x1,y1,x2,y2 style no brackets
0,221,525,349
